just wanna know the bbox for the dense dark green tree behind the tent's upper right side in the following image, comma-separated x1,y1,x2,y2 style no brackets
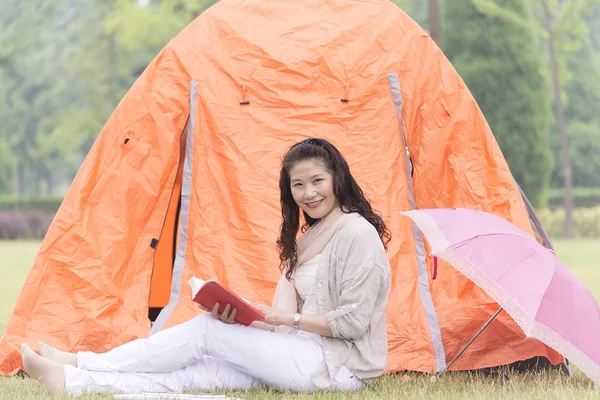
444,0,552,206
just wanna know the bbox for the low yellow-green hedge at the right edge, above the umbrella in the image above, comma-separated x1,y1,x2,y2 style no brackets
537,206,600,238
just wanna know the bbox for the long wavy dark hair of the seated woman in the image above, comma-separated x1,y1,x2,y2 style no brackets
277,138,392,280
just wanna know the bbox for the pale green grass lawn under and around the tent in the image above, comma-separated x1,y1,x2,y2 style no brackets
0,240,600,400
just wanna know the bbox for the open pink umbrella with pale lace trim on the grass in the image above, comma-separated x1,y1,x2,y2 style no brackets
400,209,600,385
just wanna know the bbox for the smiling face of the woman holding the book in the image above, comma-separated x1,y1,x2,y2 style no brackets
290,160,338,219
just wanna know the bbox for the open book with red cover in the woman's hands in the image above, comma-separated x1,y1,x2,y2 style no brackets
188,276,265,325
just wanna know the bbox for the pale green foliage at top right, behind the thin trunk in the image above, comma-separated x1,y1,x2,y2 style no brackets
473,0,600,202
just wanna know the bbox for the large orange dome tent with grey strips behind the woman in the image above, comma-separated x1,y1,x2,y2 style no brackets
0,0,562,375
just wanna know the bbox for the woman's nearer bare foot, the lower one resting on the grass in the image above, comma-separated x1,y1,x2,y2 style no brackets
21,343,67,393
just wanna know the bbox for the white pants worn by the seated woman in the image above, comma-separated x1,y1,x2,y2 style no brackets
65,314,363,395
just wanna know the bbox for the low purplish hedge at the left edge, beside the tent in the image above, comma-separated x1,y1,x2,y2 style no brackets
0,211,54,240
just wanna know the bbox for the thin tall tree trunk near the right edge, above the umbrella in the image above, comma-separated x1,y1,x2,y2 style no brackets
542,1,573,238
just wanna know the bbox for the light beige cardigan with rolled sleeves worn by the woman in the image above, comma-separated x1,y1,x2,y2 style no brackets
274,217,391,389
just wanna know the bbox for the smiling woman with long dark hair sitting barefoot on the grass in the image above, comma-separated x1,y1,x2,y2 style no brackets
22,139,391,395
